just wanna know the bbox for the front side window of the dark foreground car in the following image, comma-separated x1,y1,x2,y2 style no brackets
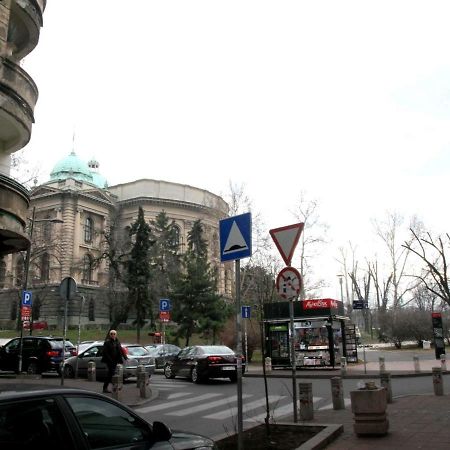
66,397,152,449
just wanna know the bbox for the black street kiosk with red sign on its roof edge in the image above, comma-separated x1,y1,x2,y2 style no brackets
264,298,350,368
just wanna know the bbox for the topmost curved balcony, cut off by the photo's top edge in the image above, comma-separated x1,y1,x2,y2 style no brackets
8,0,47,61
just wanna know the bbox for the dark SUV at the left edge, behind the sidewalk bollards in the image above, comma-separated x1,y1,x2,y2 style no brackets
0,336,76,374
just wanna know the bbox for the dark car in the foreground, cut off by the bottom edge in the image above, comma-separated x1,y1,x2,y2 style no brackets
0,384,217,450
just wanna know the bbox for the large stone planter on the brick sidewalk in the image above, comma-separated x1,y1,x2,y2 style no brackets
350,386,389,436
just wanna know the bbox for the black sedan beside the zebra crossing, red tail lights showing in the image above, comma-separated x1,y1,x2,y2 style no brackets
164,345,245,383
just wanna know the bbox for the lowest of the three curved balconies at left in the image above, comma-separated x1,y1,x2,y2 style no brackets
0,174,30,256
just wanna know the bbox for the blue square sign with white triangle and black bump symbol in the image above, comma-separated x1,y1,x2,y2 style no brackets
219,213,252,262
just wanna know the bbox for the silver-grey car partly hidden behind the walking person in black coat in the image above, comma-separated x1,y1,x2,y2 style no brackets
64,341,155,380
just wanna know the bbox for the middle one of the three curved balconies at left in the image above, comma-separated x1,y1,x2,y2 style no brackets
0,58,38,154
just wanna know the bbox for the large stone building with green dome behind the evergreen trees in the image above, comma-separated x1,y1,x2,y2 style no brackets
0,151,233,328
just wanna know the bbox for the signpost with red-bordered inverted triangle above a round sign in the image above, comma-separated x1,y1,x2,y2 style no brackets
269,222,305,423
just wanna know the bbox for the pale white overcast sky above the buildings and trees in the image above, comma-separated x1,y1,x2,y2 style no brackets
19,0,450,297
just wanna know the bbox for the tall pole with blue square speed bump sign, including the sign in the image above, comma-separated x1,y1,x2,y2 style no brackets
219,213,252,450
